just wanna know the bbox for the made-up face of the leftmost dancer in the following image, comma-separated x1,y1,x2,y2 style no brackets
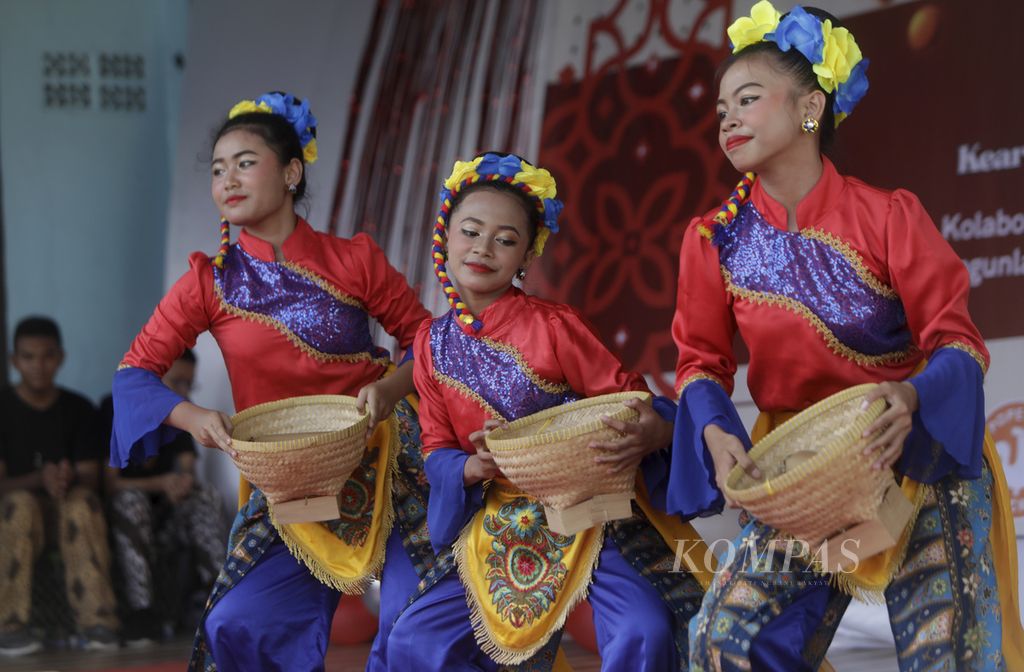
210,129,301,226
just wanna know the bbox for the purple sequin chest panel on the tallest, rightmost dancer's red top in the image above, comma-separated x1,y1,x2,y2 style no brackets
713,201,910,355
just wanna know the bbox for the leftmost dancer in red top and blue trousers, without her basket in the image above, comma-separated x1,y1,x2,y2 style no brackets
111,92,433,671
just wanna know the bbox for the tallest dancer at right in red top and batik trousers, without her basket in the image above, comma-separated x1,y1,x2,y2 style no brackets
668,2,1024,672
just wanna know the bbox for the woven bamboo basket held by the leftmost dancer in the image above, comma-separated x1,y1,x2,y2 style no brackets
231,394,370,504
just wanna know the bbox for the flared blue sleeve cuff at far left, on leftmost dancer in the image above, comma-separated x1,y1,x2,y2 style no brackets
111,368,185,468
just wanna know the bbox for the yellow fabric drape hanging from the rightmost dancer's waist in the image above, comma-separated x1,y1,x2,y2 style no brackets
751,412,1024,670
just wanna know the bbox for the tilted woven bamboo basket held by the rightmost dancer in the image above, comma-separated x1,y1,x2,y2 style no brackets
725,384,895,541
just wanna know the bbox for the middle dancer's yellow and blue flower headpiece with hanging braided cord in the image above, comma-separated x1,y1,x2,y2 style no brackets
431,153,562,331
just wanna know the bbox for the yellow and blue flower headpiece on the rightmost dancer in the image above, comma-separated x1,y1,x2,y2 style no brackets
726,0,868,126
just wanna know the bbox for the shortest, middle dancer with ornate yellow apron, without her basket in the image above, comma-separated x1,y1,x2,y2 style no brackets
388,153,711,671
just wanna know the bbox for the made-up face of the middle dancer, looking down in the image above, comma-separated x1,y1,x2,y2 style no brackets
447,188,534,310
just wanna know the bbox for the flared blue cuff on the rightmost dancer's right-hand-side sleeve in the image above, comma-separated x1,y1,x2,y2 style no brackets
909,347,985,484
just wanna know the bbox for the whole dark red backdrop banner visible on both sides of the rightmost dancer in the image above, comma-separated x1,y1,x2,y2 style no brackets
527,0,1024,393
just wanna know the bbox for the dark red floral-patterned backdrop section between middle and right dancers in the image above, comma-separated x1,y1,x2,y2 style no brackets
526,0,736,394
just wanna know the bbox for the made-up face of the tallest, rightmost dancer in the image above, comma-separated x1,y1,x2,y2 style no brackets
716,56,810,172
